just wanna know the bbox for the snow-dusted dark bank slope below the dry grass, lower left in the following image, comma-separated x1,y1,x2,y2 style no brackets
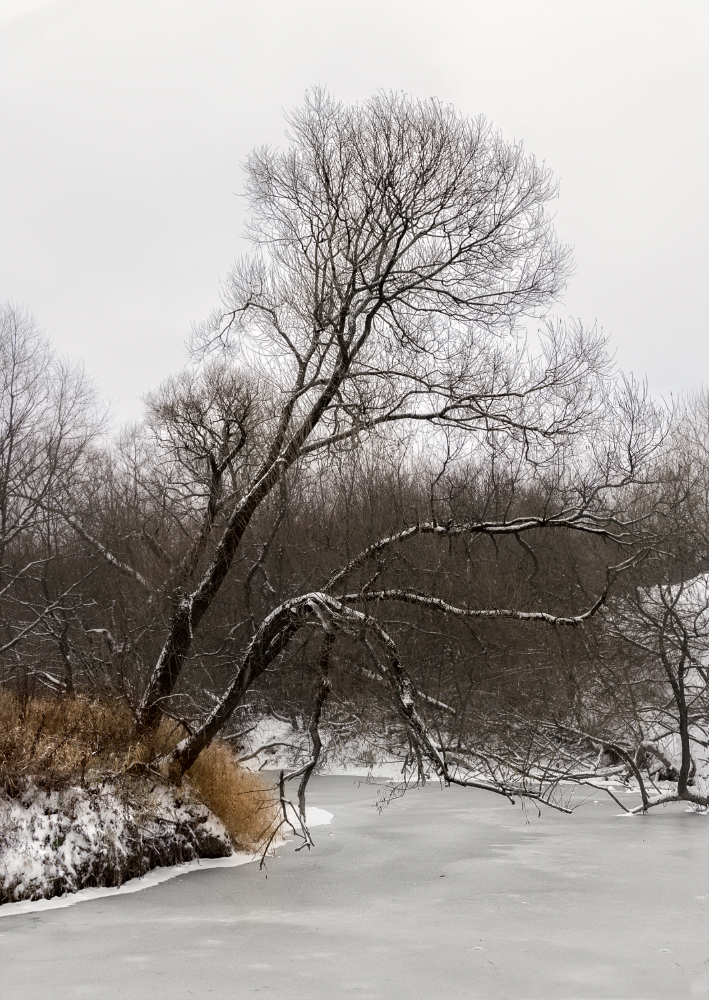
0,780,232,903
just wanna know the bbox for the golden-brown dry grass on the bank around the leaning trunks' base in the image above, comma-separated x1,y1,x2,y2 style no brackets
0,691,278,850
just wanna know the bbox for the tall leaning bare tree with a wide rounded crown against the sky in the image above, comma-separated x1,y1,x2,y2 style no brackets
133,93,599,727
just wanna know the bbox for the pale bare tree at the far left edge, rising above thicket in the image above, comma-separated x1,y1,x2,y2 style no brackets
0,303,101,690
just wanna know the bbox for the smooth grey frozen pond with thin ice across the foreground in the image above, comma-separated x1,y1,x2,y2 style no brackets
0,777,709,1000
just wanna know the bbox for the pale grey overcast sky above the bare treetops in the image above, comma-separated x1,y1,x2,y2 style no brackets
0,0,709,419
